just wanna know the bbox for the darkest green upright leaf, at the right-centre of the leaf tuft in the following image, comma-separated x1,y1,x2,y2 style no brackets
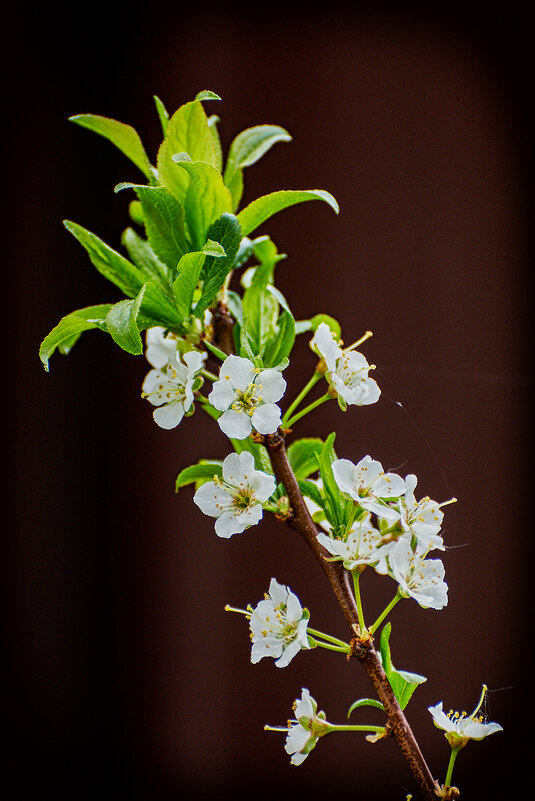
195,212,241,318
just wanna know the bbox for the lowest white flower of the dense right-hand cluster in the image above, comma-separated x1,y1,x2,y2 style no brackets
388,535,448,609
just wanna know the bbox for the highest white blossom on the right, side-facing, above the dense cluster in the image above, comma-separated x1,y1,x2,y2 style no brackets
310,323,381,409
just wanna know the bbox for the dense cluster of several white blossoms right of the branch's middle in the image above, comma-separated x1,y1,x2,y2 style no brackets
318,456,448,609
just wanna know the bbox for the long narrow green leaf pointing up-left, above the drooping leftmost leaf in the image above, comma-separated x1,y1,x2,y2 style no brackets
64,220,182,328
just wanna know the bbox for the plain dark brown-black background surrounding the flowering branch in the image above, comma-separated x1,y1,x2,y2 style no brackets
3,4,531,801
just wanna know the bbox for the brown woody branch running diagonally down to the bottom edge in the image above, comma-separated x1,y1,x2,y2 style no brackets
265,433,439,801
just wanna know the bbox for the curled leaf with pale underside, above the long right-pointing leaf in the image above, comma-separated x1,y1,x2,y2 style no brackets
224,125,292,209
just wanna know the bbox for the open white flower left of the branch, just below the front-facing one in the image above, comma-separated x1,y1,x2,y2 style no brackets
193,451,276,538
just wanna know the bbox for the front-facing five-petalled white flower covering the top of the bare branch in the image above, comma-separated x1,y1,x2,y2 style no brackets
208,355,286,439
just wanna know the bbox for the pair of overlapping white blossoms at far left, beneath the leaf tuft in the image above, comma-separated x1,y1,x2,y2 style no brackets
142,326,206,429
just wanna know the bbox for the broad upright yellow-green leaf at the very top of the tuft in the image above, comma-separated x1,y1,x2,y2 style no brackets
157,98,226,206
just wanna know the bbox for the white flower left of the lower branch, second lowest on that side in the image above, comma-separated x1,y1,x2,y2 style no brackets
249,578,309,667
